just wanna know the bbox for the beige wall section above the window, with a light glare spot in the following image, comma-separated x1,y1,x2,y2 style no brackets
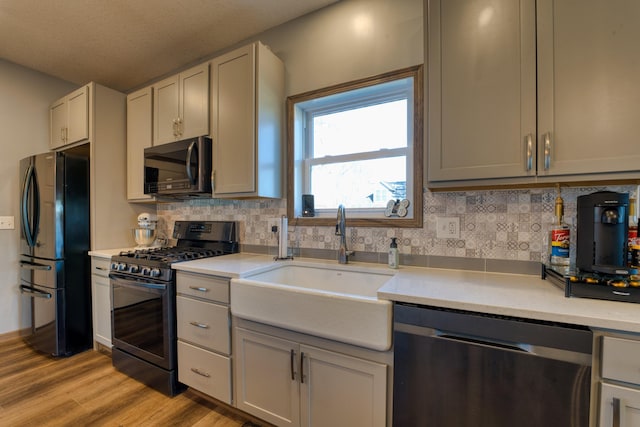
218,0,424,96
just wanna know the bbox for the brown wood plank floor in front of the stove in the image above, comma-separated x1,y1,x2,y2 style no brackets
0,338,254,427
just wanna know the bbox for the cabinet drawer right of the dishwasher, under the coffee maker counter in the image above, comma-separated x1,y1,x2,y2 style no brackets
602,337,640,384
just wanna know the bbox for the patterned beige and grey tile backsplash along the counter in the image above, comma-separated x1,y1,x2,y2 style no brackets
158,185,638,268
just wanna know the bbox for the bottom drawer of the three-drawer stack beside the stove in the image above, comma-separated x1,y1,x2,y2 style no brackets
178,341,231,404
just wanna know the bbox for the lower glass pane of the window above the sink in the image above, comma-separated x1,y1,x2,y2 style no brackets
311,156,407,209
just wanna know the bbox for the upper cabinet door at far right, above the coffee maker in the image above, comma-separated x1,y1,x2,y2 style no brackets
538,0,640,175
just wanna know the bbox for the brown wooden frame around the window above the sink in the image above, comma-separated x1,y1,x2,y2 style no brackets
286,65,424,228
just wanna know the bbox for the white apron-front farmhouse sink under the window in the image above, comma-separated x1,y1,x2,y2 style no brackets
231,264,393,350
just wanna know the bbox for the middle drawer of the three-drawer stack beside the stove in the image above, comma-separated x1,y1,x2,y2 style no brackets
177,296,231,354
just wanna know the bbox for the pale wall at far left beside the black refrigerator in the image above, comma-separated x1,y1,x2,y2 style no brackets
0,59,75,335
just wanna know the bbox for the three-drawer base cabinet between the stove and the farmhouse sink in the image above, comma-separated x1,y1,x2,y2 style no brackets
176,271,232,404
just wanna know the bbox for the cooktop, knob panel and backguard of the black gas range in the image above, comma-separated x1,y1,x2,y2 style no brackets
110,221,239,282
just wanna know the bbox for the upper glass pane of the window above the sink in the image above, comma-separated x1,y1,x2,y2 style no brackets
312,99,407,158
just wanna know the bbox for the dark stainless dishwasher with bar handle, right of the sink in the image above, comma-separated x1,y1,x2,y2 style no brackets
393,303,592,427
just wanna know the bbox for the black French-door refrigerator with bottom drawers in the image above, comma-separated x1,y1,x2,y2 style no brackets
20,151,92,356
